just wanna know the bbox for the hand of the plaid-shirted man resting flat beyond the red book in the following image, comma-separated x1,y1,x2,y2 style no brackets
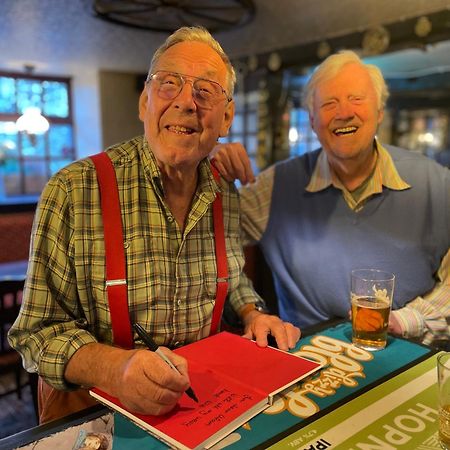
244,310,301,351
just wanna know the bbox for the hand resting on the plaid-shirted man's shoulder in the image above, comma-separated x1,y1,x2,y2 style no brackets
209,142,255,184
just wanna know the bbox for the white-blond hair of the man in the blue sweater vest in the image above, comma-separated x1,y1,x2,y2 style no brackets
303,50,389,114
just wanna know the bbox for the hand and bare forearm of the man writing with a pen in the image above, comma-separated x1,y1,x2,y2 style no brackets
64,344,190,415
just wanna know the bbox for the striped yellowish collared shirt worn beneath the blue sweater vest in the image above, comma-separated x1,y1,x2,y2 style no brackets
240,142,450,344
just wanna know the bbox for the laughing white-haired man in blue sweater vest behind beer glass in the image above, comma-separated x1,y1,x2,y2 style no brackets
214,51,450,345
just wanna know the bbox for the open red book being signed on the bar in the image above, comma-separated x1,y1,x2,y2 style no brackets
90,332,320,449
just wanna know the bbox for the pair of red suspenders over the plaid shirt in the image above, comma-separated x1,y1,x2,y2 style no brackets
91,152,228,348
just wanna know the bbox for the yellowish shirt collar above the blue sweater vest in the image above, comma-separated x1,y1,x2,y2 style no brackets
305,140,411,194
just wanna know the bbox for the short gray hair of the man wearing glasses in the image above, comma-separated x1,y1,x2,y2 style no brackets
149,26,236,97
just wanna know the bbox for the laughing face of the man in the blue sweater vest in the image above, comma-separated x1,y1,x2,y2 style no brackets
310,63,383,164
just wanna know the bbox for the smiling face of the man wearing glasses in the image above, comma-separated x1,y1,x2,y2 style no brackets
139,41,234,170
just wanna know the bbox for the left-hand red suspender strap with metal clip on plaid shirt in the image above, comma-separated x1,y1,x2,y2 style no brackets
91,152,133,349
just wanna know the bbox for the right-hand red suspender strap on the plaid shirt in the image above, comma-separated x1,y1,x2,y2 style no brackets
209,164,228,336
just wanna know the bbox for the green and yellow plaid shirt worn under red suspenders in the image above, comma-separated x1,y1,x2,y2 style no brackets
9,137,259,388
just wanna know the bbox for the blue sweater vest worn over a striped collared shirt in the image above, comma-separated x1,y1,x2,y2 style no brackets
260,146,450,327
